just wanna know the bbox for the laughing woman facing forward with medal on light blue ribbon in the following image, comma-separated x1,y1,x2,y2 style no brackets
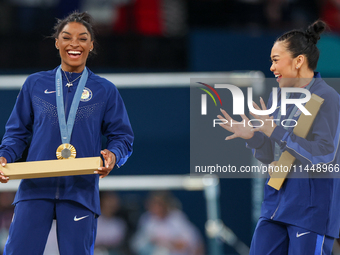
0,12,133,255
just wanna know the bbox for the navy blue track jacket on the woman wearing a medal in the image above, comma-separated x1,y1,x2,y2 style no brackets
0,68,134,215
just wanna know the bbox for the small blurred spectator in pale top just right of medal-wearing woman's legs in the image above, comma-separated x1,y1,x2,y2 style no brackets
95,192,127,255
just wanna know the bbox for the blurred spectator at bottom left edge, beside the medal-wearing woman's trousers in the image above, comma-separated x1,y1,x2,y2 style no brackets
0,192,15,254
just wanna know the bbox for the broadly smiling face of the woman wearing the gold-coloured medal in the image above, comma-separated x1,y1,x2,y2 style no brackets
55,22,93,73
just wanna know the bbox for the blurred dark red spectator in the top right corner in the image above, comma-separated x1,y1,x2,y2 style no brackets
321,0,340,33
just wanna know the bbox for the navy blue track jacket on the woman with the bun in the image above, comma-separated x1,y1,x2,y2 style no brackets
247,73,340,237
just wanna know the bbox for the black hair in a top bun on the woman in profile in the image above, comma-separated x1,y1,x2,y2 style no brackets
276,20,327,70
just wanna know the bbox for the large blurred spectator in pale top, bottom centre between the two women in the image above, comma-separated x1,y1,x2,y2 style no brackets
132,192,204,255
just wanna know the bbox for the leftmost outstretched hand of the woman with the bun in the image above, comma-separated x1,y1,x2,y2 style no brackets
217,109,254,140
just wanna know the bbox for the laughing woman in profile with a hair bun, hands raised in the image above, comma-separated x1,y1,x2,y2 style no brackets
218,20,340,255
